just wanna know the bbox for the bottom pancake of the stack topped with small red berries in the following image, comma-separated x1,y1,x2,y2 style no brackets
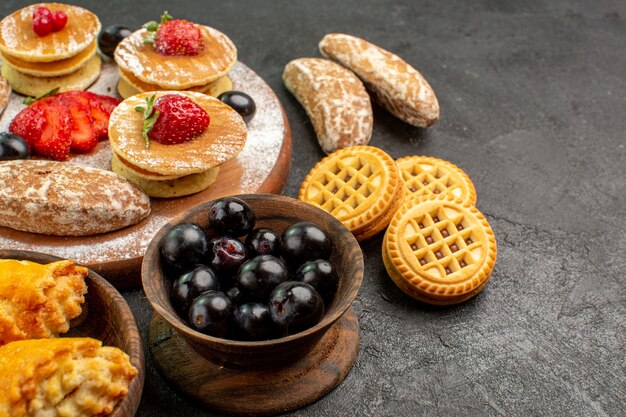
2,54,102,97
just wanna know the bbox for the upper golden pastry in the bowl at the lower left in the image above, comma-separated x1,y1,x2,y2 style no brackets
0,259,88,344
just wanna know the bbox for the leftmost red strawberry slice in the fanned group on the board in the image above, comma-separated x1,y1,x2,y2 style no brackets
9,100,72,161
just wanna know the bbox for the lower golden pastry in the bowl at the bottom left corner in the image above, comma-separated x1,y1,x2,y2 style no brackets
0,338,137,417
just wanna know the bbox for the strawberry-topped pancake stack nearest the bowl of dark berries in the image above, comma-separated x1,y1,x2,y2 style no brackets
109,91,248,198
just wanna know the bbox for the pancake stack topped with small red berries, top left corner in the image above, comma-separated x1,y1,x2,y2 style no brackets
0,3,101,97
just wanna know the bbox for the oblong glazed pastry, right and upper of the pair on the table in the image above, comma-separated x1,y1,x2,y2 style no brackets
319,33,439,127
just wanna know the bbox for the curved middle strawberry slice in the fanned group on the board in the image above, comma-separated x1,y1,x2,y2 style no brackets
51,93,98,153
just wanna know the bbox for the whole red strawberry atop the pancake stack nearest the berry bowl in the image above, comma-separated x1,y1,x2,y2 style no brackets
148,94,210,145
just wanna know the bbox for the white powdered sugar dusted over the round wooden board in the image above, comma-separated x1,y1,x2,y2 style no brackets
0,61,287,270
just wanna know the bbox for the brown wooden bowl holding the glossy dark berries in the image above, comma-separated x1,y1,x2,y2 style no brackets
141,194,363,370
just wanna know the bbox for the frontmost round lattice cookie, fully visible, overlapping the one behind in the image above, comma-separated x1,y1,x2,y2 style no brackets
382,194,497,304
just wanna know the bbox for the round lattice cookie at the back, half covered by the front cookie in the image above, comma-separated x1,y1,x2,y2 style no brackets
396,156,476,205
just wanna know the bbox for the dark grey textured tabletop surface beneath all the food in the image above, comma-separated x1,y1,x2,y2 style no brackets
0,0,626,416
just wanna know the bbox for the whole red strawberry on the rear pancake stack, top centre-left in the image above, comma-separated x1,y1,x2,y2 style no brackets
154,20,204,55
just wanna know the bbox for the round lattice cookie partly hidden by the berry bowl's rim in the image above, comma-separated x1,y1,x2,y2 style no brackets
299,146,404,240
